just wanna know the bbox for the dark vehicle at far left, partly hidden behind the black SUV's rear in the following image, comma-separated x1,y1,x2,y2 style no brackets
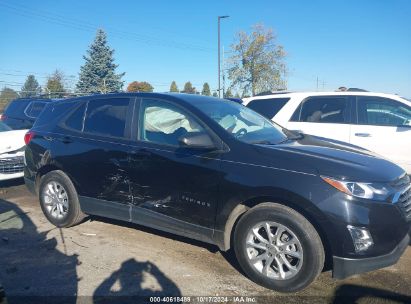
0,98,53,130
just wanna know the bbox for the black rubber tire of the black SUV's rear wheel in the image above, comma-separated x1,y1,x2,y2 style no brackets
39,170,86,227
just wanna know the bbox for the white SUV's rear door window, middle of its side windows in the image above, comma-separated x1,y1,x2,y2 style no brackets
292,96,351,124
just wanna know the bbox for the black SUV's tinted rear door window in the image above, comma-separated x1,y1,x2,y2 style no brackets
83,98,130,137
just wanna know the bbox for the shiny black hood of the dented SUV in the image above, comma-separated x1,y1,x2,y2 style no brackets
259,135,404,182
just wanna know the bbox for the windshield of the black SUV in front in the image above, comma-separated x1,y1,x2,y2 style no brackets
193,100,287,144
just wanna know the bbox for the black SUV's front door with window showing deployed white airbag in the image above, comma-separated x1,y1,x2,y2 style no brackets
130,98,222,230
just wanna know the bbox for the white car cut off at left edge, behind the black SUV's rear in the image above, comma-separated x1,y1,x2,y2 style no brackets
0,122,27,181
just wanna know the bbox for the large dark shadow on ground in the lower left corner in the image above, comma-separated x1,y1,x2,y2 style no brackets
0,199,78,304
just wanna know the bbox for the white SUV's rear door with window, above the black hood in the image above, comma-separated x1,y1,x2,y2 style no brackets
287,96,352,142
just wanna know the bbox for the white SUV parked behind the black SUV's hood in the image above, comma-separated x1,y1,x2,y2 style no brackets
243,92,411,174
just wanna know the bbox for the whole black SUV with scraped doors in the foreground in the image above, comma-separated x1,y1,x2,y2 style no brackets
25,93,411,292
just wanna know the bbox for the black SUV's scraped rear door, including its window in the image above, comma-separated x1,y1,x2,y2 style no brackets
57,97,134,219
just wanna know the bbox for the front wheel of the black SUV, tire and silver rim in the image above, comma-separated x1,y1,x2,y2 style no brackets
234,203,324,292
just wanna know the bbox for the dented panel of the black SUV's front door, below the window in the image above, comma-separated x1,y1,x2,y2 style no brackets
130,143,222,228
